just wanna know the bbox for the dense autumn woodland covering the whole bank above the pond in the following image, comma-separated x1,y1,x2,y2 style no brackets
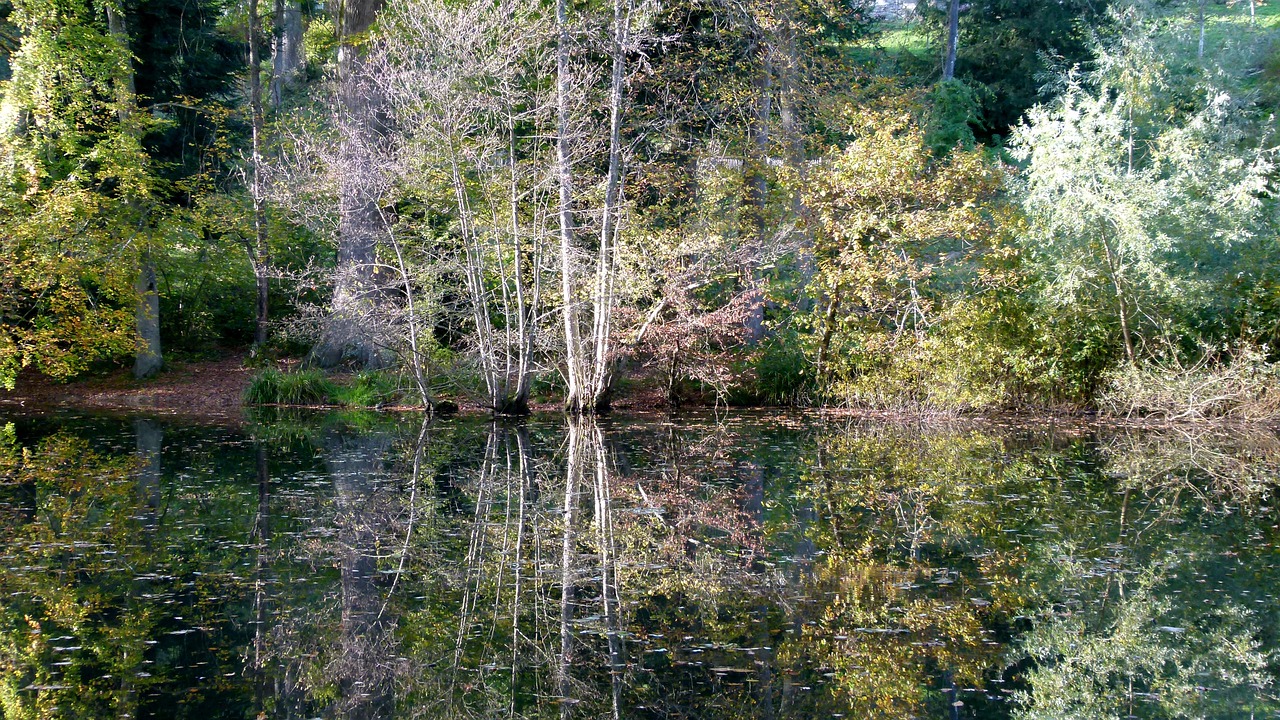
0,0,1280,420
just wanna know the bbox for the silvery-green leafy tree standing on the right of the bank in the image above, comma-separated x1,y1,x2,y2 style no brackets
1014,33,1272,364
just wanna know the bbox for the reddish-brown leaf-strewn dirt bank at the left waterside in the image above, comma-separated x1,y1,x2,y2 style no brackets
0,354,253,420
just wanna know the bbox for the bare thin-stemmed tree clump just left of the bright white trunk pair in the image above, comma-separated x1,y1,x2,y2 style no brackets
371,0,550,413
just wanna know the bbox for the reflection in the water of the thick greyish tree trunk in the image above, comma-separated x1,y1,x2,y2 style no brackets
325,433,392,719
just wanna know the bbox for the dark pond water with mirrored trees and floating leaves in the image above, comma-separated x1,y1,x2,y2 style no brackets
0,415,1280,720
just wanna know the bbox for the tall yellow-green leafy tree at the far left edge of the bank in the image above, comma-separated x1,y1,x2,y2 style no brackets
0,3,165,387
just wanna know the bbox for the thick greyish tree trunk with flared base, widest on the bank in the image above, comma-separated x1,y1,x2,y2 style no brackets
310,0,387,368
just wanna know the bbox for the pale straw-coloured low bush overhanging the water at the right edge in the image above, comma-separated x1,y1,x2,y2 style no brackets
1098,346,1280,421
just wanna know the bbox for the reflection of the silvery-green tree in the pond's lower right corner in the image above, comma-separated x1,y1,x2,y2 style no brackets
1015,552,1272,720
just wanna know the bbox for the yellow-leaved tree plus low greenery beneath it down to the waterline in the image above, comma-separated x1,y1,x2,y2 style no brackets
804,105,1010,409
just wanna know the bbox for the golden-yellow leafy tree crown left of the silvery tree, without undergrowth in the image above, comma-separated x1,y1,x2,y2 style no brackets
806,104,1004,392
